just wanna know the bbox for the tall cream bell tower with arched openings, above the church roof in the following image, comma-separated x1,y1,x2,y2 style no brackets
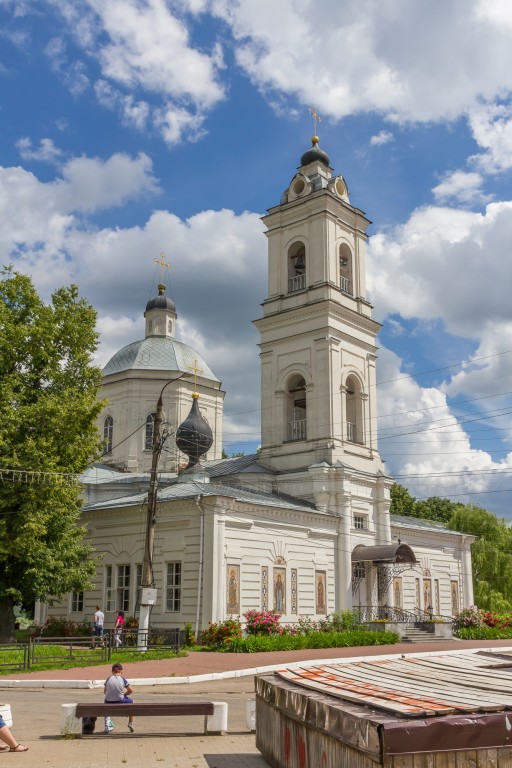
255,136,382,473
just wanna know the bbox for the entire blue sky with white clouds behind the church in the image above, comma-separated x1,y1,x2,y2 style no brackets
0,0,512,519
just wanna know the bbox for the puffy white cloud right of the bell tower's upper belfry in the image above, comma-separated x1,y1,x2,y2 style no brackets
368,202,512,339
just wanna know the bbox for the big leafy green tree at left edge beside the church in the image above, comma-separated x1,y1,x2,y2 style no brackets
0,268,102,643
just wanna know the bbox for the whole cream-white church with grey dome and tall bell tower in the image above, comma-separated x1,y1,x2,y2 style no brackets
48,137,474,628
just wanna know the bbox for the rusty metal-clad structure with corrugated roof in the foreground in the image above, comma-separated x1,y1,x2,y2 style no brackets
255,653,512,768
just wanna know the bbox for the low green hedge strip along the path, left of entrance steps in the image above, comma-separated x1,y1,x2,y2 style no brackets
222,629,400,653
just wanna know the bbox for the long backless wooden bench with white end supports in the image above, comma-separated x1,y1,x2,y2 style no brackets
61,701,228,735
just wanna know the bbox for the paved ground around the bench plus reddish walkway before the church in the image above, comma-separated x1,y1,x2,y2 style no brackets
0,640,511,768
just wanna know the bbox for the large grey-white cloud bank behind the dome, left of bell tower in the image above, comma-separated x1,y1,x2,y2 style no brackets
0,155,266,440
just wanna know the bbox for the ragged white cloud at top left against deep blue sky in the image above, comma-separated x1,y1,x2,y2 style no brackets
48,0,224,144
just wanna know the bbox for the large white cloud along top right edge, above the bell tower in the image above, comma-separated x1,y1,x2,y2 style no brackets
213,0,512,121
